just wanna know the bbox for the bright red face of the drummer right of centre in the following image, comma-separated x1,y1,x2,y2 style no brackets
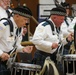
53,15,65,27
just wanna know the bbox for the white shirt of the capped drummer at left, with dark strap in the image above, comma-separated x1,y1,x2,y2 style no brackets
0,17,23,55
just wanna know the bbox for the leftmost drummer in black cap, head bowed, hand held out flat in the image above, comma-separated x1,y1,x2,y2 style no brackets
0,6,33,75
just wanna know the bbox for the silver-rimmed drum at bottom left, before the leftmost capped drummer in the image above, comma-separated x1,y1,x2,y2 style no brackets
11,62,41,75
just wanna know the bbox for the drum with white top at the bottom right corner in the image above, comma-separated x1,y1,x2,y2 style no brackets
63,54,76,75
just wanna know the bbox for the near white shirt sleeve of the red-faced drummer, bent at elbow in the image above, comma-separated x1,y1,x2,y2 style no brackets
31,25,52,50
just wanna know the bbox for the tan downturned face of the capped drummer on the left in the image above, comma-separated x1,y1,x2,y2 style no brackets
16,15,29,27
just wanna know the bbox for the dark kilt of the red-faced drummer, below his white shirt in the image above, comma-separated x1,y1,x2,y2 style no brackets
32,50,63,75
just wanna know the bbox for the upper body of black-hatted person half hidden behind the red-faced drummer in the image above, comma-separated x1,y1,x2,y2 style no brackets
61,2,71,36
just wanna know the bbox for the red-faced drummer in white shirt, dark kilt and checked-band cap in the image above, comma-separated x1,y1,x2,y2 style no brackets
32,7,72,75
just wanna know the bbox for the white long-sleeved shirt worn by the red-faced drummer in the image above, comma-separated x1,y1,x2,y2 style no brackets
32,19,67,53
